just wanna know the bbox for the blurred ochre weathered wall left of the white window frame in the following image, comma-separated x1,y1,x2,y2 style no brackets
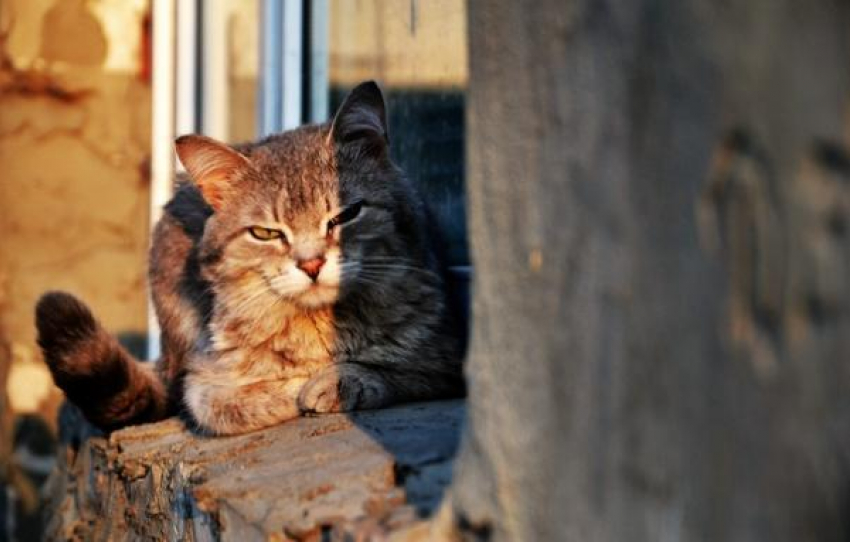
0,0,150,538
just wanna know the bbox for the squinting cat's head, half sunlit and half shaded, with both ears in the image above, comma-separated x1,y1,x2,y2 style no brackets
176,82,418,317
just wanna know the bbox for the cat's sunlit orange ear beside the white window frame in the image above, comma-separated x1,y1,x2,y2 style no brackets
174,134,252,209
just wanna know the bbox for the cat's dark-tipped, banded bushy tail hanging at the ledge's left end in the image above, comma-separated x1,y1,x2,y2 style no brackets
35,292,167,431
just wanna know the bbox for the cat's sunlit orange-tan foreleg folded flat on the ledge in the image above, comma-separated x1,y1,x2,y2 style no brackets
185,373,306,435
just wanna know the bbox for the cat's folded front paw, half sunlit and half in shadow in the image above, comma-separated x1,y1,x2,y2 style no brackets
298,364,390,413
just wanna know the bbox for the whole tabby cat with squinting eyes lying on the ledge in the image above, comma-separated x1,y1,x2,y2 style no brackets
35,82,465,435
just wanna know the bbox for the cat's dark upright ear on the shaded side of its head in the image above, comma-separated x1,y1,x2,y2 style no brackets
328,81,389,150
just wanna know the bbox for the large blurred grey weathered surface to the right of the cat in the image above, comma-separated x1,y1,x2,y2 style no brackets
444,0,850,542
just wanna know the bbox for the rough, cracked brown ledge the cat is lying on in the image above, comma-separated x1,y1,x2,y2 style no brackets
47,401,464,542
